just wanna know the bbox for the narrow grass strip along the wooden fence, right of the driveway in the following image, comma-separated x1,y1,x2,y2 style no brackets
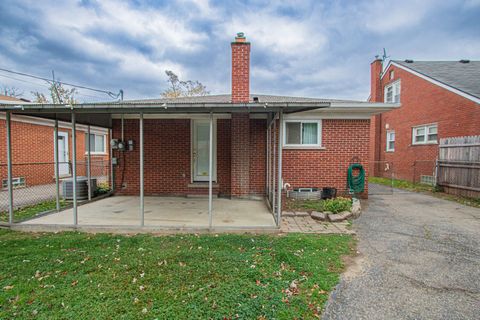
368,177,480,208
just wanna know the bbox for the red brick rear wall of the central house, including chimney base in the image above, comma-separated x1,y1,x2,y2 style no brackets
113,115,369,196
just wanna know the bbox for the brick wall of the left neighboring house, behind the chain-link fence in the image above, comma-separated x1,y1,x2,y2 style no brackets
0,120,108,186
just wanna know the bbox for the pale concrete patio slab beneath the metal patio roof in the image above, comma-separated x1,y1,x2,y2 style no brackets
20,196,276,229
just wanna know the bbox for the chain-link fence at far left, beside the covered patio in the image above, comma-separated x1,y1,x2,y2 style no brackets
0,159,111,222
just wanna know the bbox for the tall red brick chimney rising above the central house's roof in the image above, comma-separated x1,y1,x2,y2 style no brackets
232,32,250,103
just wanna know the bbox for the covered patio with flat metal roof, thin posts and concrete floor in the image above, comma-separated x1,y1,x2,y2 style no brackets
0,101,330,232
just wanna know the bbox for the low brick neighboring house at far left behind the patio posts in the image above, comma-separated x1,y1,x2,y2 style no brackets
0,95,109,189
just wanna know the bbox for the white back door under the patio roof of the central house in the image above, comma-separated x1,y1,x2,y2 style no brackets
192,120,217,181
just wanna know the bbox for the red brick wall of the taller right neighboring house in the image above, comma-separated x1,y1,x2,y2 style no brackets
372,65,480,181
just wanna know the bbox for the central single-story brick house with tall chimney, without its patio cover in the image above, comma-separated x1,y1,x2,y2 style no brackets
112,35,393,197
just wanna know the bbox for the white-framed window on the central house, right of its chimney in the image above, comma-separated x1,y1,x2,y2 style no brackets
283,120,322,147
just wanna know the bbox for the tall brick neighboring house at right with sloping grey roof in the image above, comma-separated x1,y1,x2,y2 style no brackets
370,59,480,182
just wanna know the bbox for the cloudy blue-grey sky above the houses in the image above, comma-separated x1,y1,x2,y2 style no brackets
0,0,480,101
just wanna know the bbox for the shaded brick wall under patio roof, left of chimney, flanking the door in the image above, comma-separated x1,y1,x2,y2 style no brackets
113,119,231,195
